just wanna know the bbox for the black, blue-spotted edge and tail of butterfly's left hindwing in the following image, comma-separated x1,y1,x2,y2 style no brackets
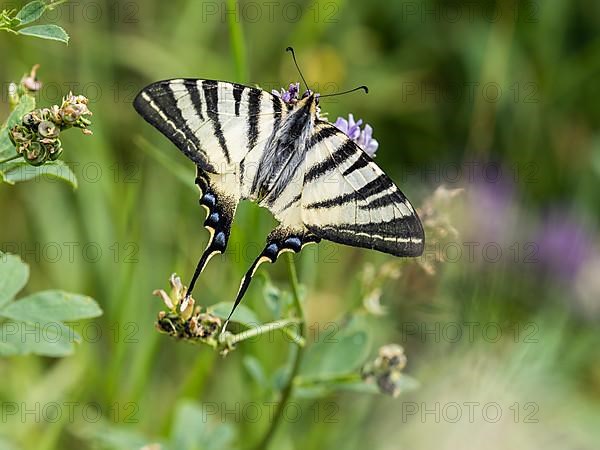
187,168,239,297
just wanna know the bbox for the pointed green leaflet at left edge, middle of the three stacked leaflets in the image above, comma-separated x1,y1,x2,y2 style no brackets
0,291,102,324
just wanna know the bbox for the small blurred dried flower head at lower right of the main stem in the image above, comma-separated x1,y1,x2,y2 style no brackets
362,344,406,397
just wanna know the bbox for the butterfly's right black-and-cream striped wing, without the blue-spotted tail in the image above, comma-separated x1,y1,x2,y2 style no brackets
301,122,424,256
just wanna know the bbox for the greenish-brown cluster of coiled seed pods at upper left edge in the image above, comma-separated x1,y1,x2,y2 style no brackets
8,93,92,166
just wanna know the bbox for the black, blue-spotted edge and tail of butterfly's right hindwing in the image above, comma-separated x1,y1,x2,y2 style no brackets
222,227,321,332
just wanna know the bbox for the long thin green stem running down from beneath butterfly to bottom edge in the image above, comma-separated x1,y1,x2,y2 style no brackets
255,253,306,450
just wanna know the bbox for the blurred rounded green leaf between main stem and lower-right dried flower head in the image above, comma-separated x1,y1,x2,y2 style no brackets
300,317,371,379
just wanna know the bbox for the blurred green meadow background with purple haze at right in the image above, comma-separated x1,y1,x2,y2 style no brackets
0,0,600,450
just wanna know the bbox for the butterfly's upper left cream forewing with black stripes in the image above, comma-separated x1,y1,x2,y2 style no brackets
134,79,285,173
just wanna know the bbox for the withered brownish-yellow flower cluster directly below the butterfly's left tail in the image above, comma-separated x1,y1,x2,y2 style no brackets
153,274,221,348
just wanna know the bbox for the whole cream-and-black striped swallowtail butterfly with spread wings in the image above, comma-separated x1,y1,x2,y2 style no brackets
134,49,424,328
